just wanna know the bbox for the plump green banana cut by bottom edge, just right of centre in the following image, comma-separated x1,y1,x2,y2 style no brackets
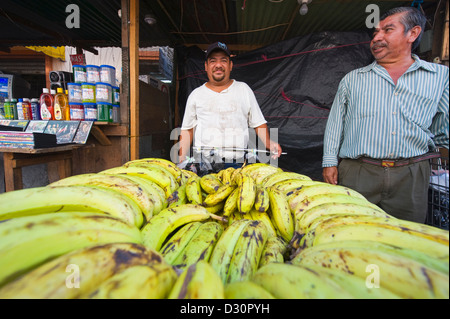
251,263,353,299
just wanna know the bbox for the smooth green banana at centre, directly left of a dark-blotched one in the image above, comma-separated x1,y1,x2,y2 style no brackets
209,219,252,284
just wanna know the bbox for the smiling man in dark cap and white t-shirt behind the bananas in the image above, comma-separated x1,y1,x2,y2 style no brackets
179,42,282,172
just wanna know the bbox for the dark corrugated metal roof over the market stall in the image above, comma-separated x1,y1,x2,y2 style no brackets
0,0,440,51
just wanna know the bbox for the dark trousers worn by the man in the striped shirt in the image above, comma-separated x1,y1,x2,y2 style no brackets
338,159,430,223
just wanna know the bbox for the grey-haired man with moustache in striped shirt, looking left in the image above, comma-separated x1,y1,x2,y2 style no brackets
322,7,449,223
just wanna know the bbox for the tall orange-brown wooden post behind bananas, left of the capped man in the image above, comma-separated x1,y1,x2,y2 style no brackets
129,0,139,160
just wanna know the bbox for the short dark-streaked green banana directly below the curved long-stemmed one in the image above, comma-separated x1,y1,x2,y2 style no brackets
159,222,202,265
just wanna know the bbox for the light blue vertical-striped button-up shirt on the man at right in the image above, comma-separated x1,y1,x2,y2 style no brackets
322,55,449,167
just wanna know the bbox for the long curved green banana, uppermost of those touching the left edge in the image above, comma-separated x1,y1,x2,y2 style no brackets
0,185,144,228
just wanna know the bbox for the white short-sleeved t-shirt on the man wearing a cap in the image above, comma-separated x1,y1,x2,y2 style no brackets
181,80,267,159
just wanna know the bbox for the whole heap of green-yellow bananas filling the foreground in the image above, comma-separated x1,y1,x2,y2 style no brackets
0,158,449,299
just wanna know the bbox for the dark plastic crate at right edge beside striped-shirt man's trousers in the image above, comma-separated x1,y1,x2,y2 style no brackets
426,157,449,230
